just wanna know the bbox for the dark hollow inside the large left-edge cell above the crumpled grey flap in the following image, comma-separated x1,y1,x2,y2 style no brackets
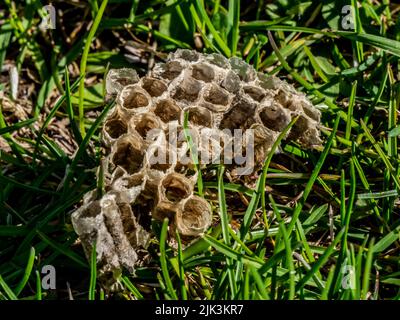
113,140,144,174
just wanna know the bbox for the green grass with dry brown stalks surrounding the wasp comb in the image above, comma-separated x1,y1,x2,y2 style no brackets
0,0,400,300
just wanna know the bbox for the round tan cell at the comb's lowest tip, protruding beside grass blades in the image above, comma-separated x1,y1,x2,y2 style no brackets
175,196,212,237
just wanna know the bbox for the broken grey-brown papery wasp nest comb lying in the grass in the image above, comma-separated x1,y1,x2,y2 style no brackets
72,50,320,284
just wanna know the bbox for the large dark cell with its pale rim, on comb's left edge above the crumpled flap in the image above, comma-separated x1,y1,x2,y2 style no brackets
112,134,144,174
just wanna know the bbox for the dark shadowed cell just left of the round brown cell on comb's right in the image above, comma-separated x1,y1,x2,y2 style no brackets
219,96,256,130
